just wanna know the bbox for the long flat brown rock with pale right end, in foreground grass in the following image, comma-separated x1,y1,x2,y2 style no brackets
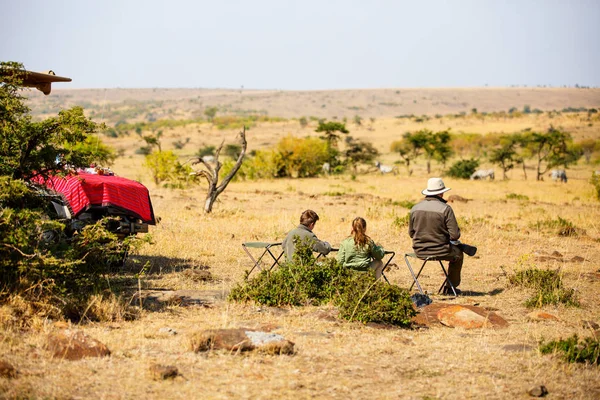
190,328,294,354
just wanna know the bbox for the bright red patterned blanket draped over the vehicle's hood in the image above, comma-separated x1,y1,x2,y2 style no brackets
40,172,154,224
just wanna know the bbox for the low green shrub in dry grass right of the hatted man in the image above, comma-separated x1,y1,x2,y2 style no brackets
508,268,579,307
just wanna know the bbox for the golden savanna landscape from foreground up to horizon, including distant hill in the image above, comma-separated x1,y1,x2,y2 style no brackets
0,80,600,399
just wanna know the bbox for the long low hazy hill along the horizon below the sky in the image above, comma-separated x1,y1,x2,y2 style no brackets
27,87,600,124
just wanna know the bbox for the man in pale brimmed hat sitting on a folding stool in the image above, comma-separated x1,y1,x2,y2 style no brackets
408,178,477,294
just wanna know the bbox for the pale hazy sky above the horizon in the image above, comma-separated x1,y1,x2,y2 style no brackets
0,0,600,90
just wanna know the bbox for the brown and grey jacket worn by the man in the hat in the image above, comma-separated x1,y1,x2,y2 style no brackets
408,196,460,258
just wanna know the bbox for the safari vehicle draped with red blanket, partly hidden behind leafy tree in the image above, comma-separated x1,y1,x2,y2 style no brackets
2,67,156,239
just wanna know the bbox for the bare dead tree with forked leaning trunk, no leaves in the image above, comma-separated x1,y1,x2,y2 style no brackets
193,126,248,213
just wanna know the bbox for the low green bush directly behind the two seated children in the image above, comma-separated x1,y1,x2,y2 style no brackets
229,239,416,326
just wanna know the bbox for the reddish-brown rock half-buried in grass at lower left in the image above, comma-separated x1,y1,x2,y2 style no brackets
47,329,110,360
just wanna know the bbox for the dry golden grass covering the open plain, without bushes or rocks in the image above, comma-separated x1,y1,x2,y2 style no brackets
0,89,600,399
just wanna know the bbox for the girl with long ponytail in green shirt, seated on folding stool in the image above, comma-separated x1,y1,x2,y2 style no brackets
337,217,385,279
